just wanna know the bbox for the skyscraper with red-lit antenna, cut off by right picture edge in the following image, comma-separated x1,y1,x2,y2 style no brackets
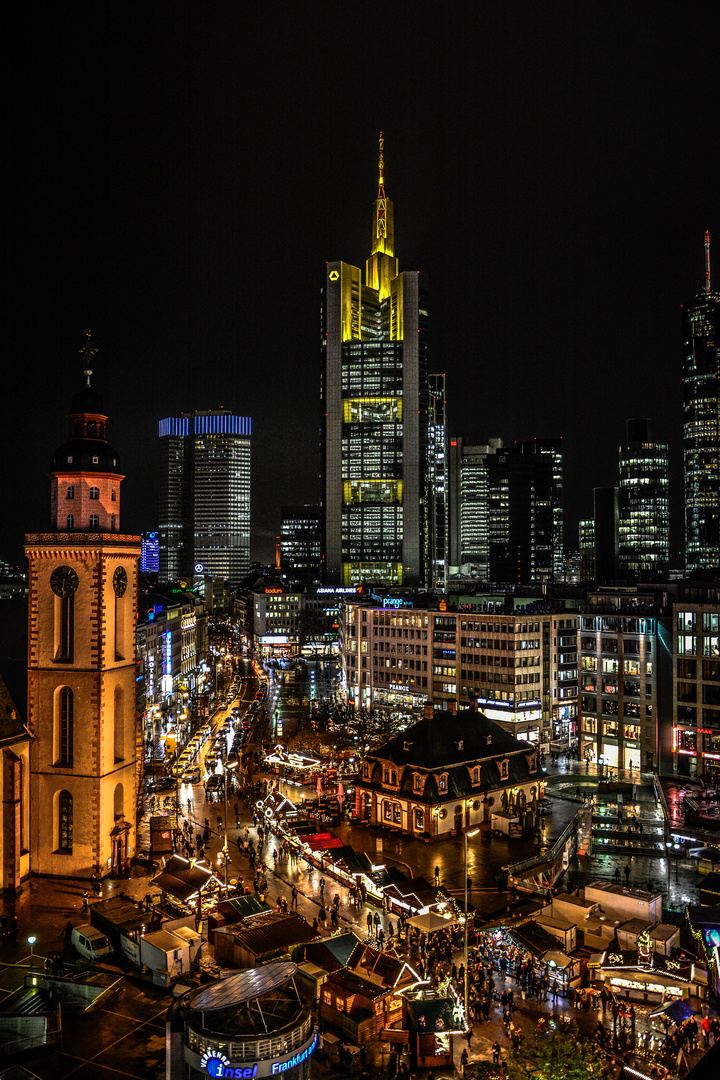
682,232,720,572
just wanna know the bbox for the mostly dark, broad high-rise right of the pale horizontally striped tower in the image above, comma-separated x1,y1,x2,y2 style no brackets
486,438,563,584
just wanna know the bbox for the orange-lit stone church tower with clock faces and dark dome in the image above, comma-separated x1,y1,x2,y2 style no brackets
25,332,142,877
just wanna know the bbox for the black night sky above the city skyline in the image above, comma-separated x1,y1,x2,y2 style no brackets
0,0,720,562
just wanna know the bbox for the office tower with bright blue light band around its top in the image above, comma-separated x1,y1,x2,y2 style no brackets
159,409,252,586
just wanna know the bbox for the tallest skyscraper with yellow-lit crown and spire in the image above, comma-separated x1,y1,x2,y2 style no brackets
321,136,432,585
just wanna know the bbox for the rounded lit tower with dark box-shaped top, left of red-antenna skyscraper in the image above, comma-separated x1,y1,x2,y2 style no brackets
617,419,670,581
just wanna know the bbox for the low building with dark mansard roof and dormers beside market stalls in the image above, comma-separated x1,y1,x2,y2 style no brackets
355,710,544,840
